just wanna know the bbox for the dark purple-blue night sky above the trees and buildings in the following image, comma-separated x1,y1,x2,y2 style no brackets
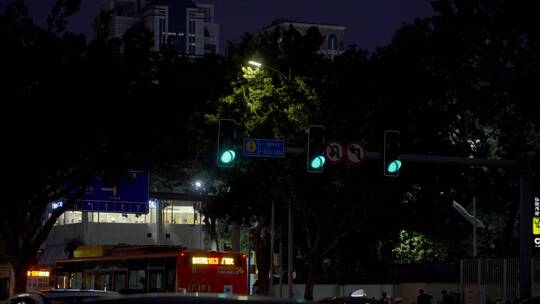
0,0,435,51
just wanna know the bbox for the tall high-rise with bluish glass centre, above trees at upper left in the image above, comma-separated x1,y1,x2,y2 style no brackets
103,0,219,56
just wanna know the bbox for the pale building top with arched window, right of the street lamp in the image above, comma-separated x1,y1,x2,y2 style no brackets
262,19,346,59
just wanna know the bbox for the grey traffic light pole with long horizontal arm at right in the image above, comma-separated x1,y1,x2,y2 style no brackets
285,148,532,299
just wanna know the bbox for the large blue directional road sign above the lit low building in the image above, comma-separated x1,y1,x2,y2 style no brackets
68,171,149,214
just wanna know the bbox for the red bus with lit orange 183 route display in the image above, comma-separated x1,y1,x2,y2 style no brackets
54,245,249,294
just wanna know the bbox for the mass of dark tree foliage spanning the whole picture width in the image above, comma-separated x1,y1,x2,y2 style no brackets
0,0,540,298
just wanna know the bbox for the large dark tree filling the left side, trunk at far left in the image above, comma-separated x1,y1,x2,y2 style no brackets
0,0,230,291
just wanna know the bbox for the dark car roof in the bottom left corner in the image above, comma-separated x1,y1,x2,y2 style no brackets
4,289,119,304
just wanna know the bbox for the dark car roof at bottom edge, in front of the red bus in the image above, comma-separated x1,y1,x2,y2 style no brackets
87,293,310,304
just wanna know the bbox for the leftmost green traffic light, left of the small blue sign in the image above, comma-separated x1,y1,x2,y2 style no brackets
217,119,236,168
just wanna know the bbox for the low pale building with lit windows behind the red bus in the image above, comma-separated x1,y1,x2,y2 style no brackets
38,200,210,266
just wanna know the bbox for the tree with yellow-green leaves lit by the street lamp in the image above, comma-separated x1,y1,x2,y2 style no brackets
207,63,316,290
